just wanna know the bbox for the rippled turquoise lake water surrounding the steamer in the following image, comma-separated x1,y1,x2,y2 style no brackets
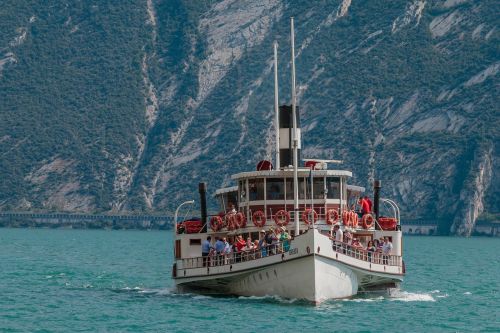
0,229,500,333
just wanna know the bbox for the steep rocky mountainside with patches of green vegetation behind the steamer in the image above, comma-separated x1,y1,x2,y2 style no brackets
0,0,500,235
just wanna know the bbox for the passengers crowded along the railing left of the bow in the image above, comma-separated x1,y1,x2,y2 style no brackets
201,227,291,266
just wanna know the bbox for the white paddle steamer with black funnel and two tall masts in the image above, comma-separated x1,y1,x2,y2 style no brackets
172,18,405,303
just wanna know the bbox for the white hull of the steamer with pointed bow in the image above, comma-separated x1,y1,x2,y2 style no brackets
176,230,402,303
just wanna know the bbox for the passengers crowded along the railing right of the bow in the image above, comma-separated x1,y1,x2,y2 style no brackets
330,224,393,264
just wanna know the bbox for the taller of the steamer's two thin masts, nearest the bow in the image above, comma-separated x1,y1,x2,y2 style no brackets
290,17,300,236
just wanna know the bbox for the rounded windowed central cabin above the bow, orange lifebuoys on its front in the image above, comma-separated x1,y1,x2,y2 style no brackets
215,168,354,232
